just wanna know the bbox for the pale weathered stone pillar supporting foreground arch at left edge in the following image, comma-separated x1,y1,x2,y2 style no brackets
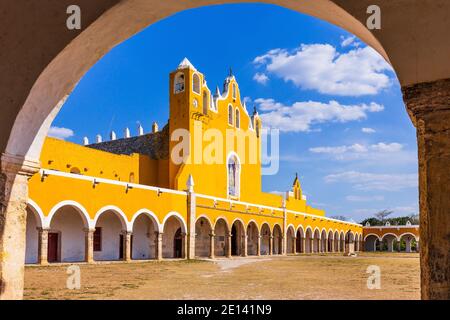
0,154,39,300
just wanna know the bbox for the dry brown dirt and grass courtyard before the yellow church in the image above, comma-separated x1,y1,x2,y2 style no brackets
25,253,420,300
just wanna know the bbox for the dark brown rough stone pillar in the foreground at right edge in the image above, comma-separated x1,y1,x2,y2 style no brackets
402,78,450,299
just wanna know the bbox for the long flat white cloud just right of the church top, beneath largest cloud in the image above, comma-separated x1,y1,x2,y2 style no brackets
255,98,384,132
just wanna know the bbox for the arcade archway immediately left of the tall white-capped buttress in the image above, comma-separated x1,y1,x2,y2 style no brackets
162,215,186,259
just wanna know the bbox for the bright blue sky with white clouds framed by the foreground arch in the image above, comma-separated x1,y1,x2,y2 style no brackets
51,4,418,221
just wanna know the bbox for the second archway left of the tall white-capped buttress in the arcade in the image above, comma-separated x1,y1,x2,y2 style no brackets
131,212,159,260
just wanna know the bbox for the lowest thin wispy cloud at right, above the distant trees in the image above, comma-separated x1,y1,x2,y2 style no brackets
325,171,418,191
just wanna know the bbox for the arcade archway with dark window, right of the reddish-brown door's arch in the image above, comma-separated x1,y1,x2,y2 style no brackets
94,208,127,261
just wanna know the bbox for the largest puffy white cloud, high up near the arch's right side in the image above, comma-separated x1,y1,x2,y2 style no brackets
253,44,393,96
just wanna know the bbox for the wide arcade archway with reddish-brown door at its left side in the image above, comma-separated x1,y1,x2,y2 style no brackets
47,205,89,263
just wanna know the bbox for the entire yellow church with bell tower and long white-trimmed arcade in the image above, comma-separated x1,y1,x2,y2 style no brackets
26,59,363,264
